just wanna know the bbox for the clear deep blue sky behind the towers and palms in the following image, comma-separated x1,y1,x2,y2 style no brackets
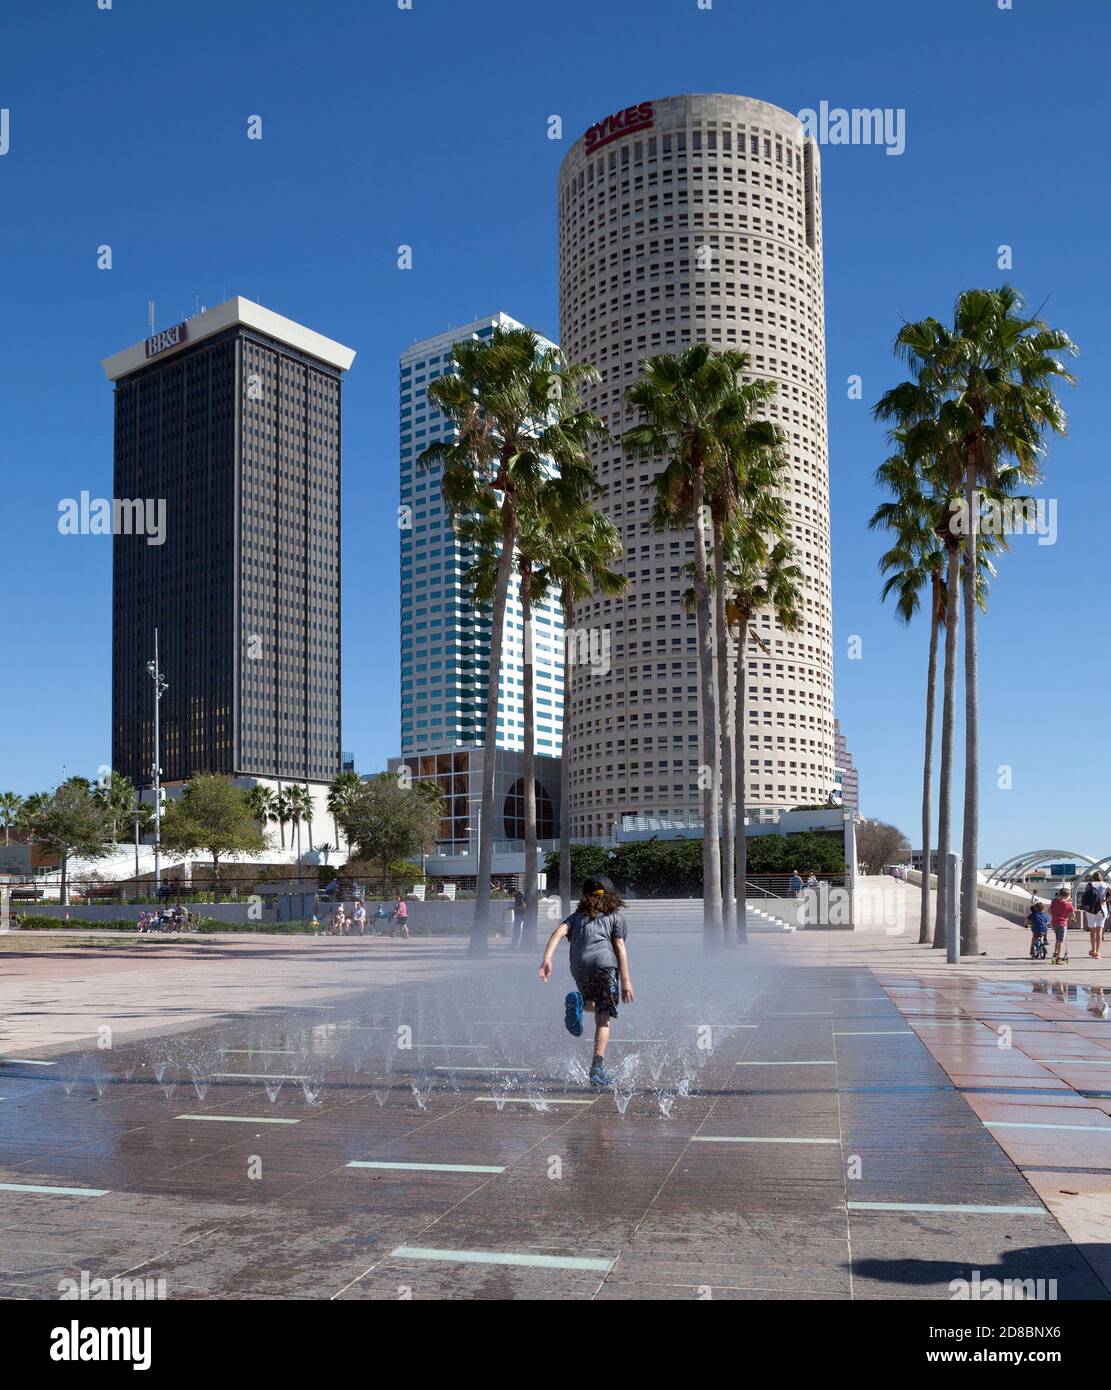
0,0,1111,859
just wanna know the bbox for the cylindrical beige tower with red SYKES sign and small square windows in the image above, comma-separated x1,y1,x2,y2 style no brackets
559,95,834,837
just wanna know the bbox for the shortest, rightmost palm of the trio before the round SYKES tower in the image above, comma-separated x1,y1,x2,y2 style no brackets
722,467,804,945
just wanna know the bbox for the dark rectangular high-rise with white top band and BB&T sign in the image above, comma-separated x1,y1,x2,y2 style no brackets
103,297,355,787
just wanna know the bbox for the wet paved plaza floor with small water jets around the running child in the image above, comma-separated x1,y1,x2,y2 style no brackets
0,933,1111,1300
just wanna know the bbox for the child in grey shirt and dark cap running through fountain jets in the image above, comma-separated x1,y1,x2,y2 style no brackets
540,877,633,1087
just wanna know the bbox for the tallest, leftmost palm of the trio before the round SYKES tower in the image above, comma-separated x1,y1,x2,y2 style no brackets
622,343,748,948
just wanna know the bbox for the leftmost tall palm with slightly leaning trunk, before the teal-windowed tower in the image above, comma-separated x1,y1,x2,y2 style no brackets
419,328,606,955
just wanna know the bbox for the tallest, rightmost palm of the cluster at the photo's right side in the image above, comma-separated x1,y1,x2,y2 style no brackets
877,285,1076,955
